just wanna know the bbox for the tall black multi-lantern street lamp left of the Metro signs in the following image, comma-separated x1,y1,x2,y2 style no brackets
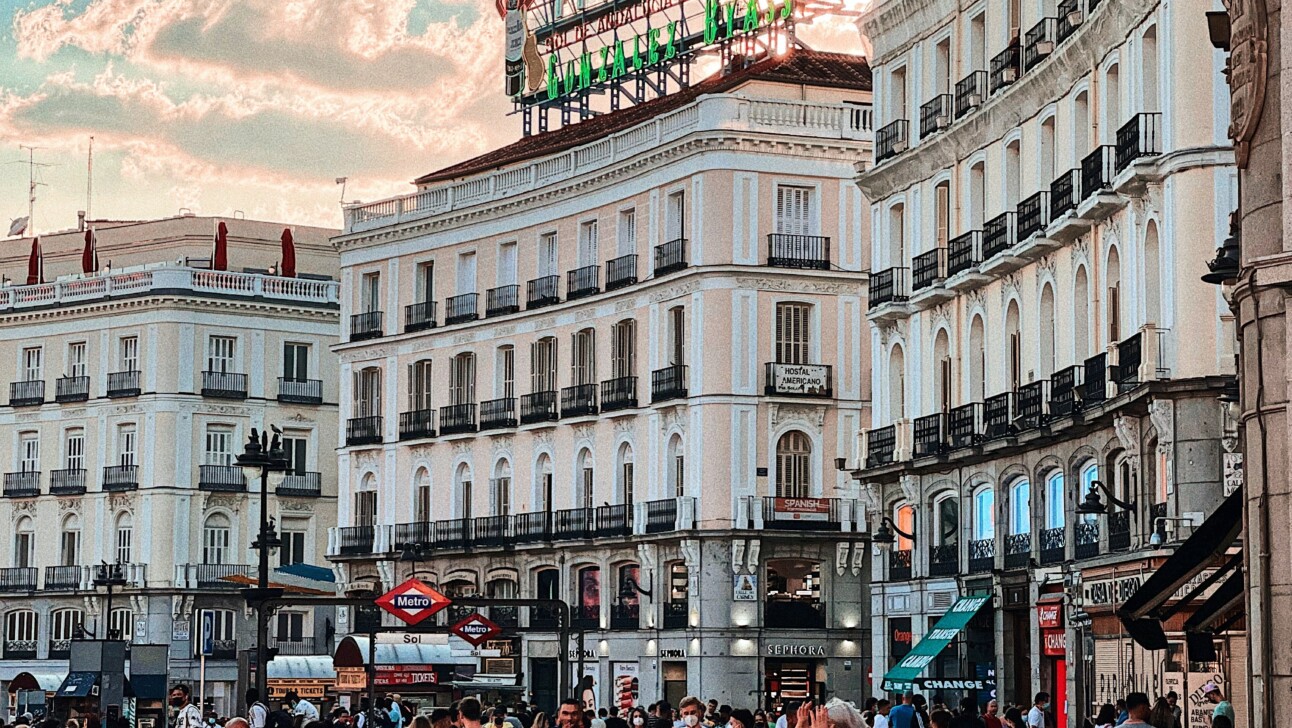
238,425,287,700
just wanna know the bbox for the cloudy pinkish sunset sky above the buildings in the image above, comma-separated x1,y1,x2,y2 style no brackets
0,0,863,235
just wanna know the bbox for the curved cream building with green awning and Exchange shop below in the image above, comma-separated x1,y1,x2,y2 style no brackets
858,0,1247,725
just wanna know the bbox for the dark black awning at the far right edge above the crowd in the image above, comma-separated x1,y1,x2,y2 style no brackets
1118,490,1243,649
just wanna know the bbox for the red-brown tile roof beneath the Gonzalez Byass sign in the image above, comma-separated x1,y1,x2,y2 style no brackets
413,48,871,185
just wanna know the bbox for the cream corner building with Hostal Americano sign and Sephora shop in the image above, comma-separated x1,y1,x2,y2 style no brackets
329,50,871,709
